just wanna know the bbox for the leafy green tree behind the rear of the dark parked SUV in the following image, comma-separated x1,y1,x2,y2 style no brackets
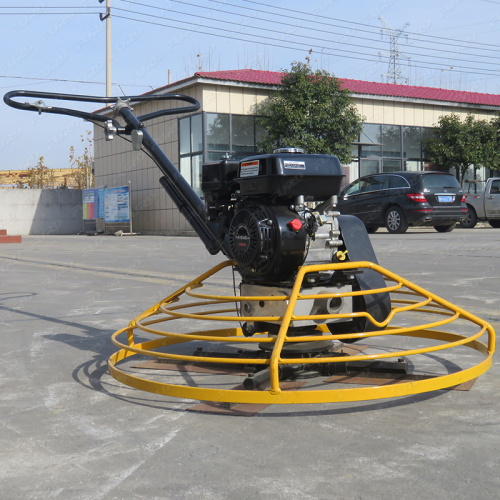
424,113,500,187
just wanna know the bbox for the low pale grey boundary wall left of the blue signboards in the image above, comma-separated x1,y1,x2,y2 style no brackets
0,189,83,235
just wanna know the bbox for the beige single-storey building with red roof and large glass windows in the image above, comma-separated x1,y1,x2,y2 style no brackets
94,70,500,235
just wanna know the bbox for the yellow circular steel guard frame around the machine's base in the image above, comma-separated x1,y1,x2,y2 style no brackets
108,261,495,404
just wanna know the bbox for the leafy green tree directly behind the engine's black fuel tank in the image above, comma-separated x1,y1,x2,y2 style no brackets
256,62,363,163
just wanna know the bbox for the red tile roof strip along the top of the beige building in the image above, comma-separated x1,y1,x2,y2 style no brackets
195,69,500,106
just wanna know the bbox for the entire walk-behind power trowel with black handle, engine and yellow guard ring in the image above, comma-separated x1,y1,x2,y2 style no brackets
4,91,493,403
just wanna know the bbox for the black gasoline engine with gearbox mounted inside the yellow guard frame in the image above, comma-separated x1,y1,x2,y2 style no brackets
202,148,390,338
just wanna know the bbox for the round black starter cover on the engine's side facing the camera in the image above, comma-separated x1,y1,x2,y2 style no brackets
228,200,308,284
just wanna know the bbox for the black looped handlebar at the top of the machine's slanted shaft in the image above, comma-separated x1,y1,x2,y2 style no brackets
3,90,200,122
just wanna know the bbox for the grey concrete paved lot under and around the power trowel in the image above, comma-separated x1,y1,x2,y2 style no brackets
0,227,500,500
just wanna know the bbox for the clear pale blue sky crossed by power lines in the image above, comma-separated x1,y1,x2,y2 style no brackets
0,0,500,170
